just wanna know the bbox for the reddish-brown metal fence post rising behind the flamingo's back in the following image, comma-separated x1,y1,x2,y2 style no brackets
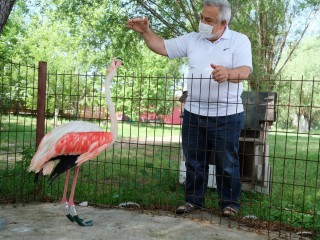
36,62,47,147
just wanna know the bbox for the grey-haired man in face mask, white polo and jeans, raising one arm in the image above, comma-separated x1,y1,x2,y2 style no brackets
126,0,252,216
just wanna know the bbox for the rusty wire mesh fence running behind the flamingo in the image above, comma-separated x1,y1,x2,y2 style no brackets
0,62,320,238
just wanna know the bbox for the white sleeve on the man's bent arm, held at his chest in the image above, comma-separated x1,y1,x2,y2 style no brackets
232,34,253,72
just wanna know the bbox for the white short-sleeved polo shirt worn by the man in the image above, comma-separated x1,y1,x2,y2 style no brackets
164,27,252,116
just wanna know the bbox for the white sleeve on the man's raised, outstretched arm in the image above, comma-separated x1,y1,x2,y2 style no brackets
164,33,191,58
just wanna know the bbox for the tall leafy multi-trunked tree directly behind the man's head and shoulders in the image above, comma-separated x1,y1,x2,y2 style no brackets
125,0,320,90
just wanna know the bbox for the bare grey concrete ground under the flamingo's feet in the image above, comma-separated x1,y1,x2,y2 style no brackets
0,203,310,240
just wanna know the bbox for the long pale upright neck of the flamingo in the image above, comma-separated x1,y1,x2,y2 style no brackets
105,70,118,144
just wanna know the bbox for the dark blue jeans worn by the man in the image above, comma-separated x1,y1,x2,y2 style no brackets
182,110,244,209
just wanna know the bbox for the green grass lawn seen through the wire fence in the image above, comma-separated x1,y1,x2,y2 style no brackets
0,115,320,230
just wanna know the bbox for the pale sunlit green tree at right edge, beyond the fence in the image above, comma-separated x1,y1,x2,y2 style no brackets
275,38,320,131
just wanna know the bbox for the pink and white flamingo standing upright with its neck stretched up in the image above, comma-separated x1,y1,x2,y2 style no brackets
29,57,123,226
